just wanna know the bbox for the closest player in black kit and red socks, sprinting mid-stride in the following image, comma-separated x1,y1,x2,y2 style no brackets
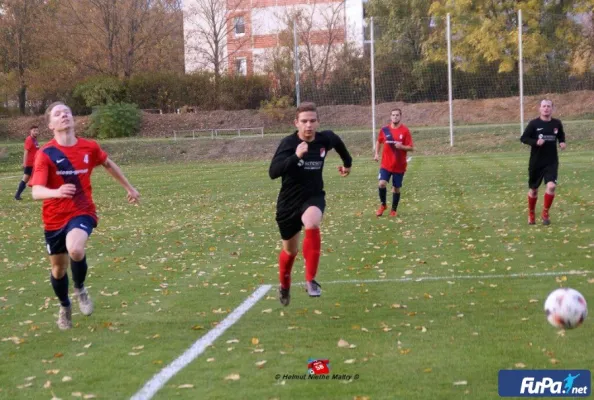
269,103,353,306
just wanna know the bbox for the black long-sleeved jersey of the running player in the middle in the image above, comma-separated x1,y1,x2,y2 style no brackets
269,131,353,213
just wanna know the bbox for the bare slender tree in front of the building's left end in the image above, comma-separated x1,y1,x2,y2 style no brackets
186,0,251,107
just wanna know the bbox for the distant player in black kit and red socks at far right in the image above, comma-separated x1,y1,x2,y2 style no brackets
520,99,566,225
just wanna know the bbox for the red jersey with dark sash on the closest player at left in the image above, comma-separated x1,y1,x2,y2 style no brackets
29,138,107,231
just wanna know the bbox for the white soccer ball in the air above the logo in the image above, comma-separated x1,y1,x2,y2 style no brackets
545,288,588,329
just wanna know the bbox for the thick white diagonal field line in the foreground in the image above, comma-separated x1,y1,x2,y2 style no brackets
130,285,272,400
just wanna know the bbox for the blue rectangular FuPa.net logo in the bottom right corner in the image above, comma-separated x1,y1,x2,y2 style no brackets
499,370,592,397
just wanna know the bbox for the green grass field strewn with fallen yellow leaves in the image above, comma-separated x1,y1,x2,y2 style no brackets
0,130,594,400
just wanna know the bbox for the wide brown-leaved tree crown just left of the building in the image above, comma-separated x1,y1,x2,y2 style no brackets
60,0,183,79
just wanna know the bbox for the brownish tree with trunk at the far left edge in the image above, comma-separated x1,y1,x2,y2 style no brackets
0,0,47,115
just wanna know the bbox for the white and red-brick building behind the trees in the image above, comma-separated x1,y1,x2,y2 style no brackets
184,0,364,75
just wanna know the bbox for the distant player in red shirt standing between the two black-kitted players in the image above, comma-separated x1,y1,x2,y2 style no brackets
374,108,414,217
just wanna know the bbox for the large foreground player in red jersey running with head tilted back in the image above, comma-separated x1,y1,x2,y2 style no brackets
29,102,140,330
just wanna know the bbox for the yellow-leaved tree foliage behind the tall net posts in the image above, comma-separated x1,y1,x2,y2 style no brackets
430,0,575,72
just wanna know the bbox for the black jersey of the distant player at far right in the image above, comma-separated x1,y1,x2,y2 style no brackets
520,118,565,168
